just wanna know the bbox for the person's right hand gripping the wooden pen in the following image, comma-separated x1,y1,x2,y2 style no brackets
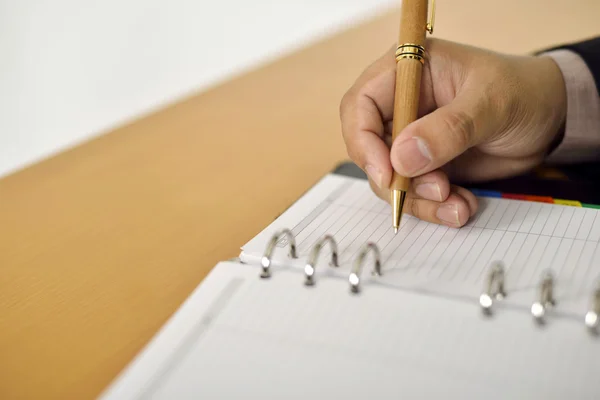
340,39,567,227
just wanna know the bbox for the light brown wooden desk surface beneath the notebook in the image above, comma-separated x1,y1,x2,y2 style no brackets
0,0,600,399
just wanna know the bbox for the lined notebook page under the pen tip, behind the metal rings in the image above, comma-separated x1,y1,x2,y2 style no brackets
241,175,600,318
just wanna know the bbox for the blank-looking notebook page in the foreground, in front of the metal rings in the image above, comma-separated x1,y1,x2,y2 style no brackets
103,263,600,400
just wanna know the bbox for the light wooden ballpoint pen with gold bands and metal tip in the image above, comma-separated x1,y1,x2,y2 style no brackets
390,0,435,233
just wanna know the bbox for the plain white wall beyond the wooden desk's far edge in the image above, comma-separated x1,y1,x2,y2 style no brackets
0,0,399,176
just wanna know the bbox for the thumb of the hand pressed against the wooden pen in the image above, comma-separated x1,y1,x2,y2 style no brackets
390,93,487,177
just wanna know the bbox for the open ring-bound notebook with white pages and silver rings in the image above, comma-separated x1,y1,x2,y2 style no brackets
102,166,600,399
